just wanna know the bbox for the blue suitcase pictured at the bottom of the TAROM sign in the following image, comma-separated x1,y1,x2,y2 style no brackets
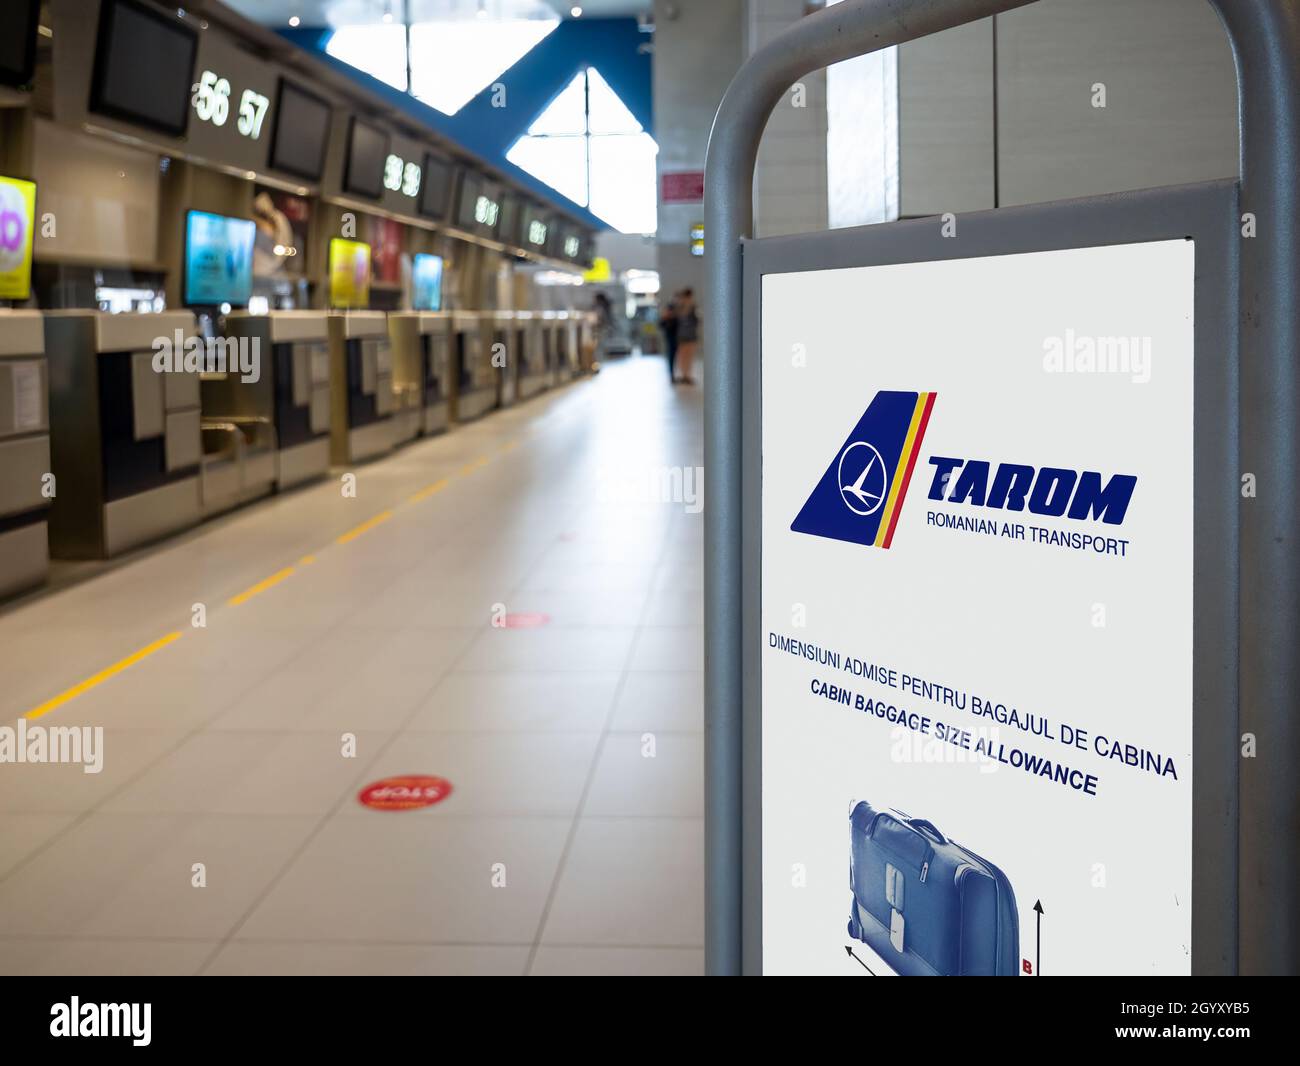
849,802,1021,978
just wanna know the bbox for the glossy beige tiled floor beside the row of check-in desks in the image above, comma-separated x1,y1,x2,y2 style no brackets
0,359,703,974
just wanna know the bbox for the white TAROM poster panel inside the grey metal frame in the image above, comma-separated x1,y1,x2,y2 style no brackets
762,241,1195,975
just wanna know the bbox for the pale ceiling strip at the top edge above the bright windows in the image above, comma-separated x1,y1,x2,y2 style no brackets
225,0,654,29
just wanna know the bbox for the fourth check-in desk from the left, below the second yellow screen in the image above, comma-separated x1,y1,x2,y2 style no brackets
329,311,394,463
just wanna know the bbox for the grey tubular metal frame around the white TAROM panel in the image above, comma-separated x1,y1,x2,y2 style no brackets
705,0,1300,974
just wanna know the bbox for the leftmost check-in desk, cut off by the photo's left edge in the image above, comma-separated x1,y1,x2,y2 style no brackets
0,311,49,597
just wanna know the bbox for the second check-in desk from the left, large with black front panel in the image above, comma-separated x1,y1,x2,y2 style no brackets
44,311,203,559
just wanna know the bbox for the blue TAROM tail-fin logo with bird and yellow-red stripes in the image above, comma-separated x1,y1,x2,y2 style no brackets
790,393,937,547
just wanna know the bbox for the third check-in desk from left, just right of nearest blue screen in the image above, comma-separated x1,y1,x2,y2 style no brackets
226,311,330,489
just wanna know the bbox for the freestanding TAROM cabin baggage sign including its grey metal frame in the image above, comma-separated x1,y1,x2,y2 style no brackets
706,0,1300,975
